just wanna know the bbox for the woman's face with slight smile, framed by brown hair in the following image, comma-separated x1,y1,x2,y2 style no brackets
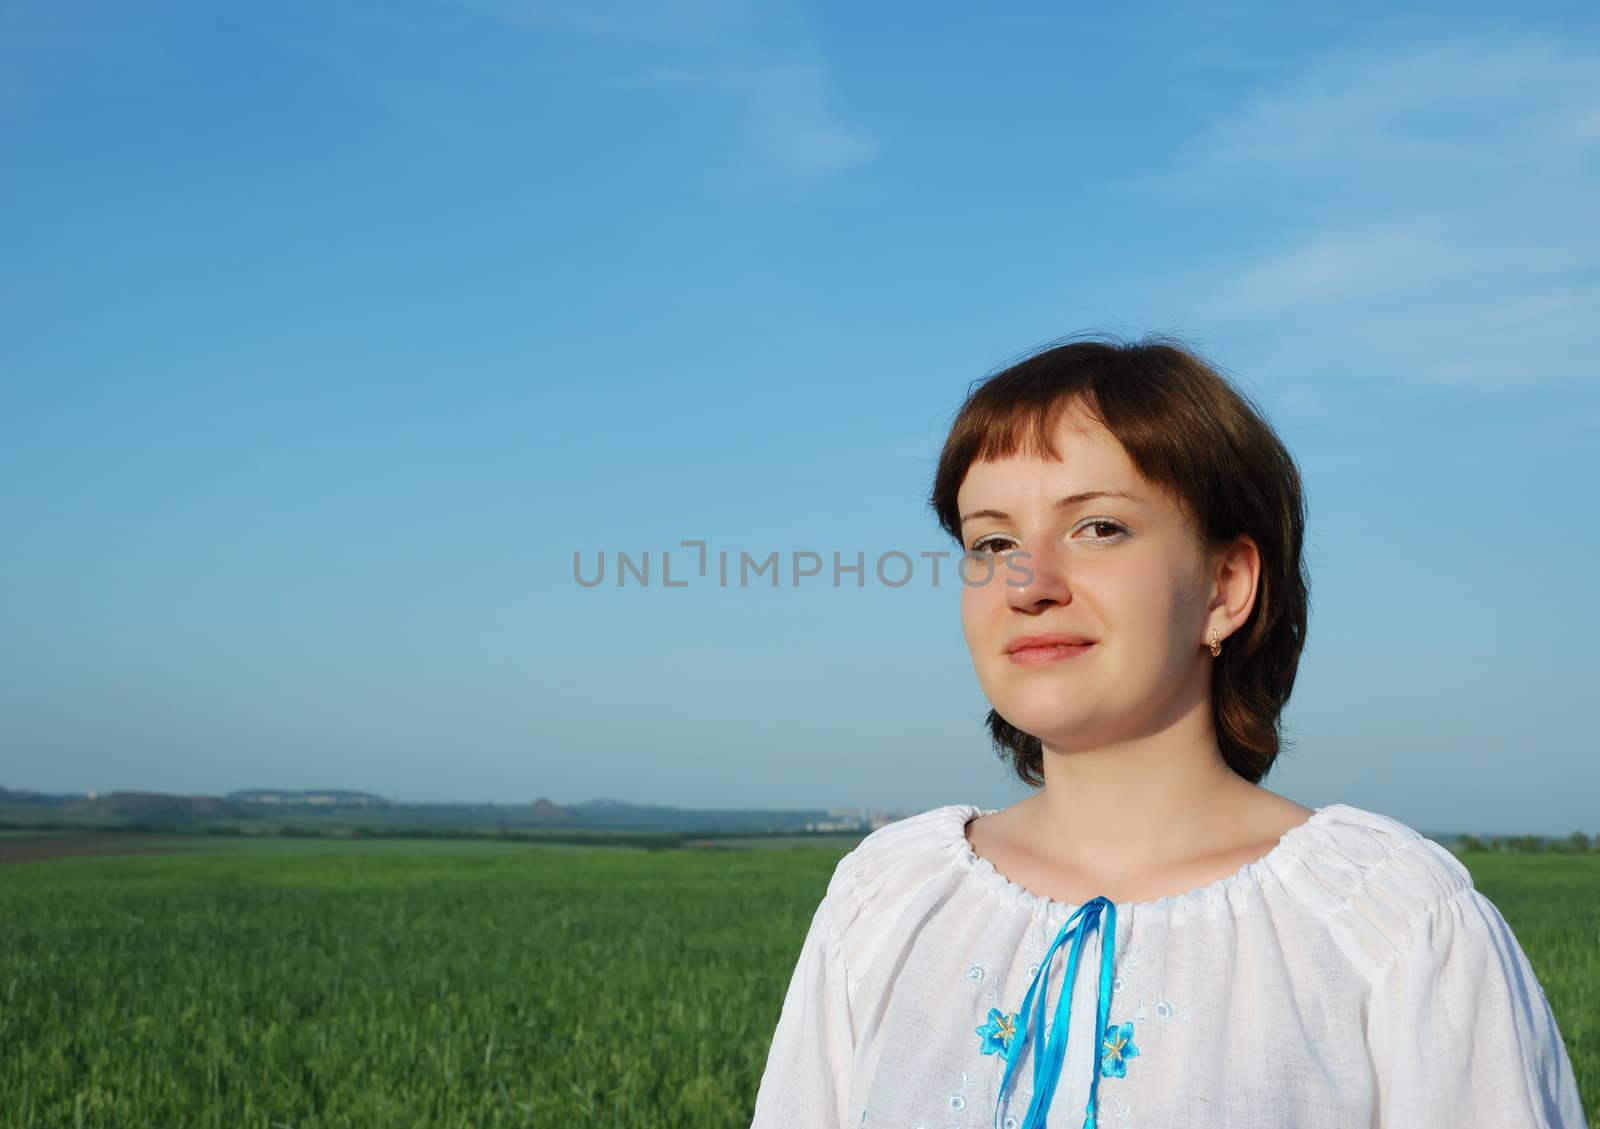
957,409,1227,750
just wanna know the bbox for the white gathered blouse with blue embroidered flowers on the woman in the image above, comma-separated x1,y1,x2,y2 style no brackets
752,804,1586,1129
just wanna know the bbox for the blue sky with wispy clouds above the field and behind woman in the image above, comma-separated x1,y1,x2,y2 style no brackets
0,0,1600,833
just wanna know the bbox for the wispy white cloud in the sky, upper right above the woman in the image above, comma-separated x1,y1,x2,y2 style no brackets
1160,35,1600,389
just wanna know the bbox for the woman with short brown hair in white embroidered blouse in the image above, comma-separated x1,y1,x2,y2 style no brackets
752,341,1584,1129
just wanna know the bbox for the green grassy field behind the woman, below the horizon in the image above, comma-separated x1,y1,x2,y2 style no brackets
0,840,1600,1129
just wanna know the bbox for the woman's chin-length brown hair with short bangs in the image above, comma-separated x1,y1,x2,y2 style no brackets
928,336,1310,787
